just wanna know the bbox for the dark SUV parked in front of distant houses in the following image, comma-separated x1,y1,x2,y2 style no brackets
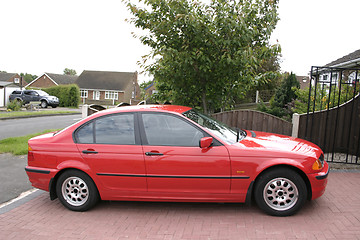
9,90,59,108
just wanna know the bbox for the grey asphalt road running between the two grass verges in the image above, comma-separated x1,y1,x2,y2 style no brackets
0,114,81,140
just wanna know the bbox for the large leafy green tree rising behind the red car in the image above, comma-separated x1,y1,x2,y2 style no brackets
123,0,280,112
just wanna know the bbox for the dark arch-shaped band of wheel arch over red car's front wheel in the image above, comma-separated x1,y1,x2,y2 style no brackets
247,164,312,202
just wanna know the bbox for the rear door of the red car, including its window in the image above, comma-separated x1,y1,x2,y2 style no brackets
75,113,146,191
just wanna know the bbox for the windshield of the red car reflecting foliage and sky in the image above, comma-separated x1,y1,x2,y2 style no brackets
183,109,244,144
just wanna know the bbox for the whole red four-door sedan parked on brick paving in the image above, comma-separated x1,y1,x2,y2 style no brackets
25,105,329,216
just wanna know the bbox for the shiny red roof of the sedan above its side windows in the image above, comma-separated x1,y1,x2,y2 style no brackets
94,105,191,115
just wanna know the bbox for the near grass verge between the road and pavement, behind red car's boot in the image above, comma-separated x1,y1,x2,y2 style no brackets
0,129,59,155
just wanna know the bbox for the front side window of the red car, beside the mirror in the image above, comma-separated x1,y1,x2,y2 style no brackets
142,113,204,147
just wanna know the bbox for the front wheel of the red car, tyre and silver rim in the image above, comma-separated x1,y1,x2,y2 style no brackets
254,167,307,216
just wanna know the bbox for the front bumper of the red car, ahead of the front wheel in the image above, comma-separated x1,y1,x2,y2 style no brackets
307,162,330,200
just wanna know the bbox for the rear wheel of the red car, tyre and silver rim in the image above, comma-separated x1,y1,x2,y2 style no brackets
56,170,99,212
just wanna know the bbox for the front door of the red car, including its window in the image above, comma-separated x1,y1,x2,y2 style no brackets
140,112,230,193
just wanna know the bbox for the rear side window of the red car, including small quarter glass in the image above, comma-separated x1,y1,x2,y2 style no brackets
75,114,135,145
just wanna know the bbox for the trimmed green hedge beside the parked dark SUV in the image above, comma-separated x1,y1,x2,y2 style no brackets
42,84,80,108
